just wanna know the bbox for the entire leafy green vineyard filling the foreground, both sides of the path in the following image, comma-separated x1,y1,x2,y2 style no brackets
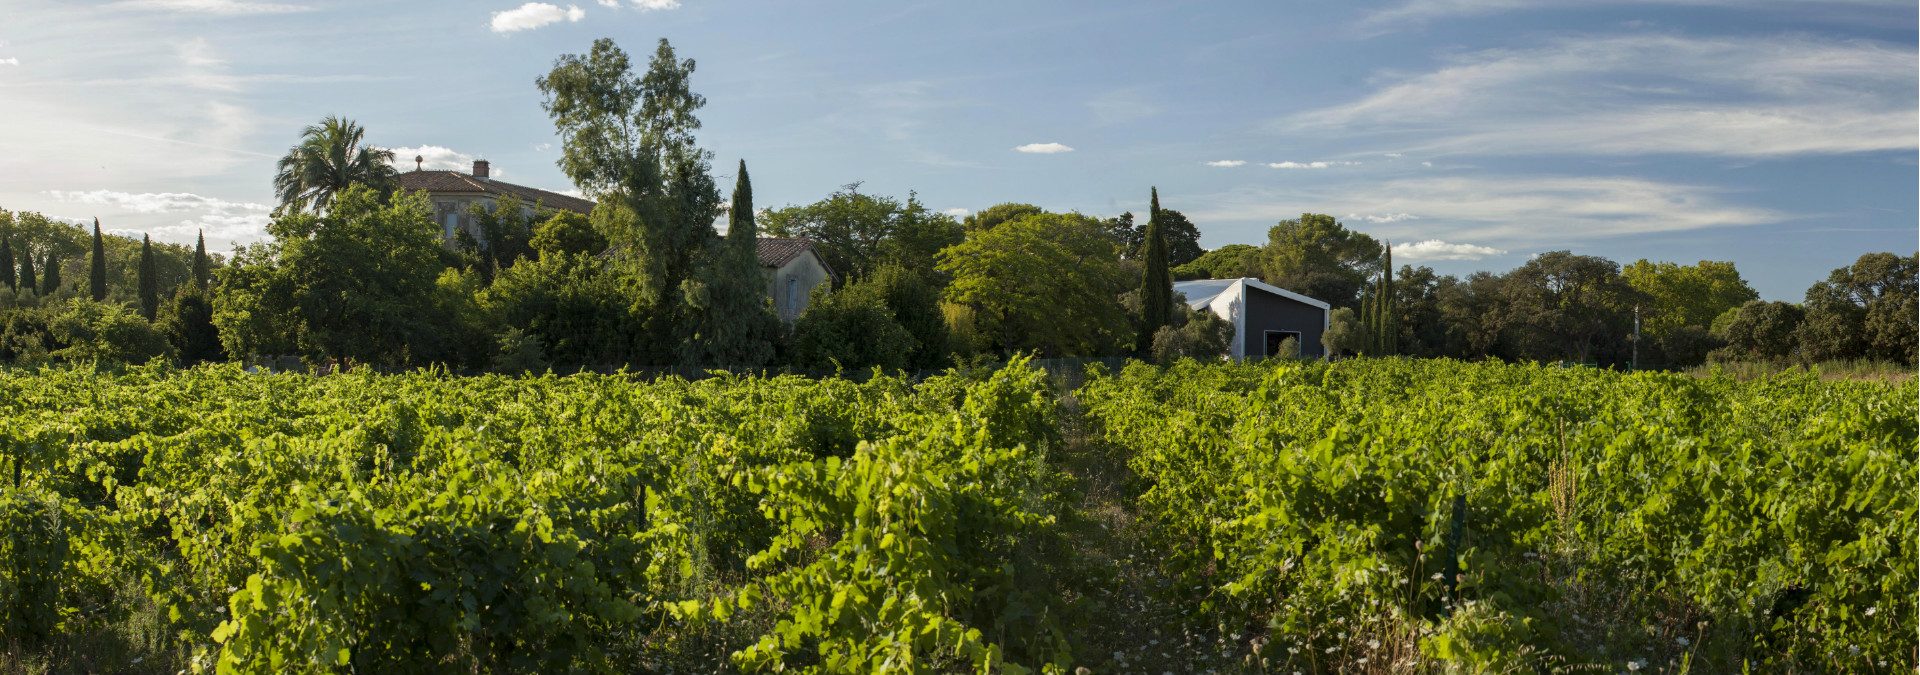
0,361,1920,673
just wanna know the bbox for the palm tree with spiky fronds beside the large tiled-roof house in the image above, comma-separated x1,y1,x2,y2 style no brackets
273,115,394,213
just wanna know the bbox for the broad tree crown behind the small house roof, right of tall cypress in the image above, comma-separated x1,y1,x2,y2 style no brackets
766,182,962,278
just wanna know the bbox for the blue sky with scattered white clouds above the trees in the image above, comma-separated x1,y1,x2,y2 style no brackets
0,0,1920,301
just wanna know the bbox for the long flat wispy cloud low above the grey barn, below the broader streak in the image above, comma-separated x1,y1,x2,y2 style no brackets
1187,175,1786,247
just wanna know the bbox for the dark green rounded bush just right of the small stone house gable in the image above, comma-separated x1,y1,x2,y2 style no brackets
789,282,920,370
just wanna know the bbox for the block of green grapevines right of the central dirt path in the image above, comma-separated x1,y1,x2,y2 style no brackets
1075,359,1920,671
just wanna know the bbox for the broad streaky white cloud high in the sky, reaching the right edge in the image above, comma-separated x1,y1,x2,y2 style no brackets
1275,35,1920,157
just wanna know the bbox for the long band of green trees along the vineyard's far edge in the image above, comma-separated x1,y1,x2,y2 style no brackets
0,34,1920,372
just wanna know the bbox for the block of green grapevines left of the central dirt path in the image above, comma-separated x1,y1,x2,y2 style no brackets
0,358,1073,671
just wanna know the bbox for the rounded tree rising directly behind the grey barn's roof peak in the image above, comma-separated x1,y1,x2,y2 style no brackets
1261,213,1380,307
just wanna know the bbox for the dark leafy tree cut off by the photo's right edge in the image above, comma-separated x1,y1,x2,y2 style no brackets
1801,253,1920,362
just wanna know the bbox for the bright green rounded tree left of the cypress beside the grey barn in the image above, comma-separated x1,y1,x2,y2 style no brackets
939,213,1133,357
